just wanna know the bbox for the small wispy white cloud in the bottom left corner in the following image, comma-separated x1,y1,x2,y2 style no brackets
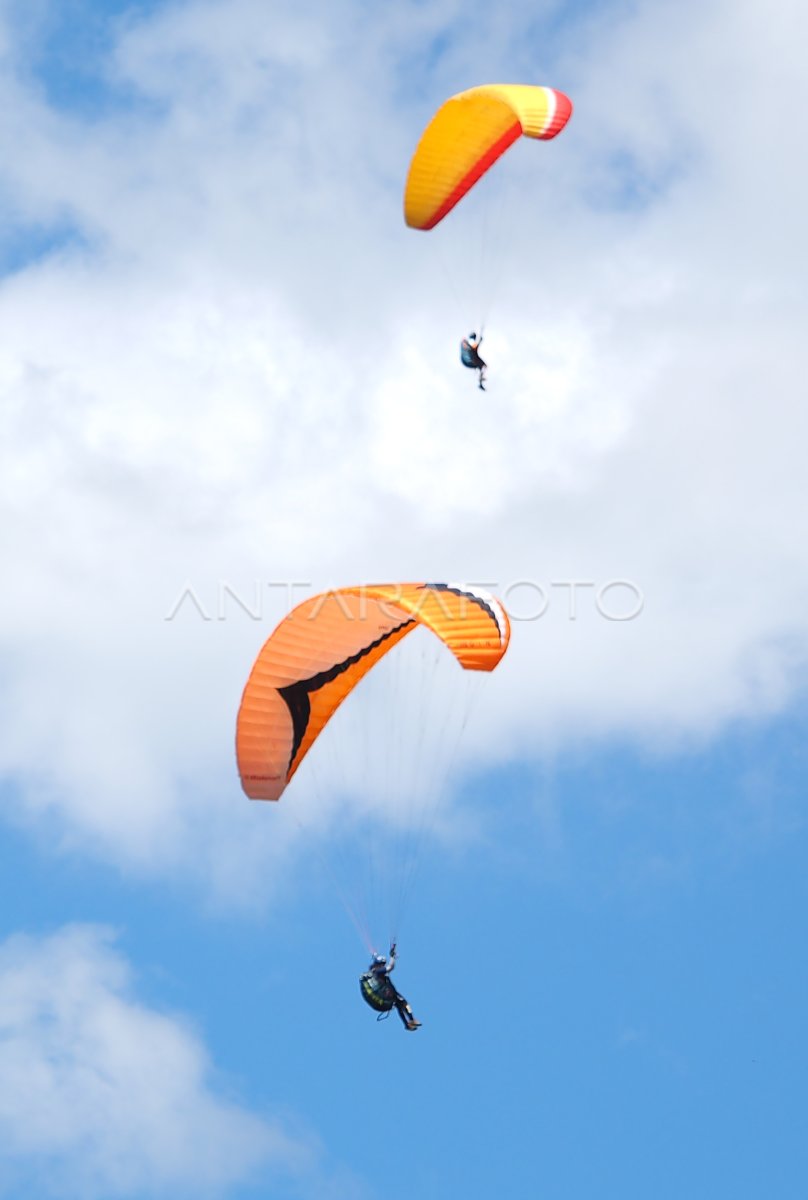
0,926,310,1198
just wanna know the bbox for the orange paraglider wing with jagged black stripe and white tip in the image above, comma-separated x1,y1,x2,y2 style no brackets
235,583,509,800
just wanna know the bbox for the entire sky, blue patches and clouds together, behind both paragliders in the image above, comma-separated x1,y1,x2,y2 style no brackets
0,0,808,1200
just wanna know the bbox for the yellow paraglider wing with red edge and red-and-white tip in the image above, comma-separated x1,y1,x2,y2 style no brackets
405,84,573,229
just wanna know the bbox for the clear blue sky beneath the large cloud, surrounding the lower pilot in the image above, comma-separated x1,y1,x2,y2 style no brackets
4,720,808,1198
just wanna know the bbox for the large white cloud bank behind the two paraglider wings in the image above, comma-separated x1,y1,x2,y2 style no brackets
0,0,808,892
